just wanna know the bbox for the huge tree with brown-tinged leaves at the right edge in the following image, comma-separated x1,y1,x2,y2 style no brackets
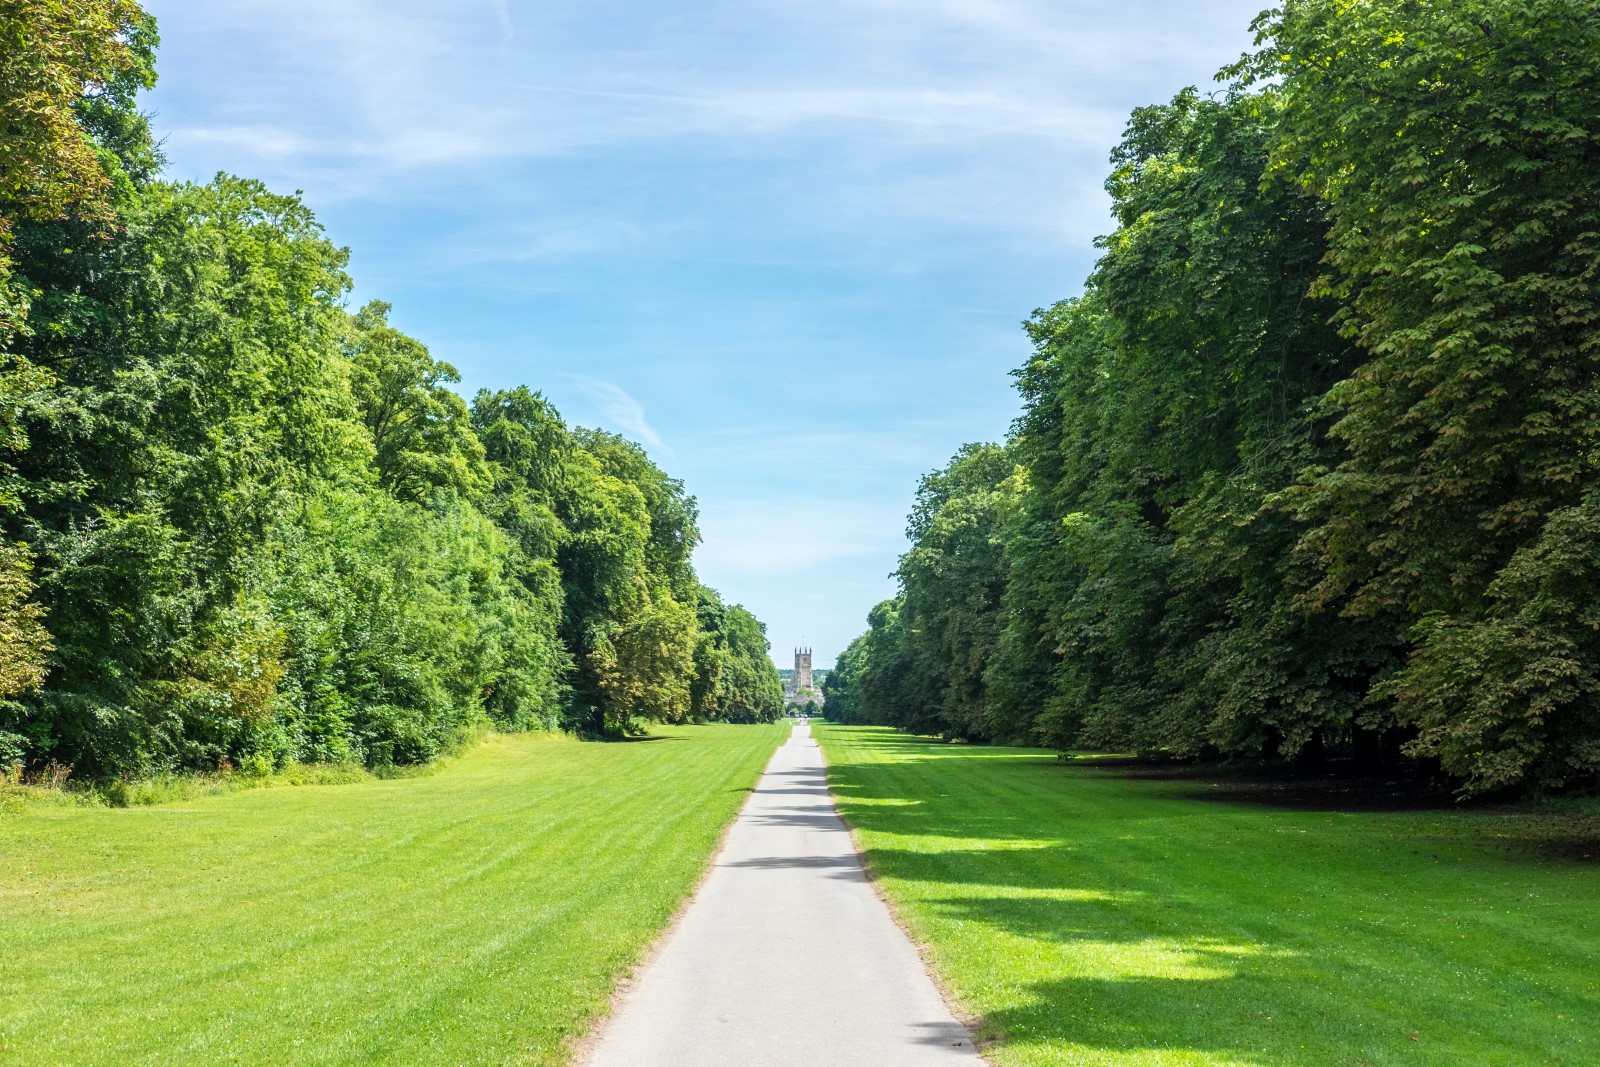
1240,0,1600,790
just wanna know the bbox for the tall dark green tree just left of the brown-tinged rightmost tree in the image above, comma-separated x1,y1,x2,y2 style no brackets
989,90,1387,755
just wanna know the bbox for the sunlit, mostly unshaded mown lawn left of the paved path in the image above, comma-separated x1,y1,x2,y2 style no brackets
0,725,787,1067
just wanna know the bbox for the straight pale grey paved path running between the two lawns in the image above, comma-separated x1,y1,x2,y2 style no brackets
589,723,981,1067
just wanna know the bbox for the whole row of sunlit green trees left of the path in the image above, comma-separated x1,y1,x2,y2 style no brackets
0,0,782,777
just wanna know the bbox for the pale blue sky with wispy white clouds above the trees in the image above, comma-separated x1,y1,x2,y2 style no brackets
146,0,1266,667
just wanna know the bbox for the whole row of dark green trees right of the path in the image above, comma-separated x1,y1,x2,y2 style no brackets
827,0,1600,792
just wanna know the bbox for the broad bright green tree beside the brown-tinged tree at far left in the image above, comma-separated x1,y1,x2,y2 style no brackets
4,178,368,773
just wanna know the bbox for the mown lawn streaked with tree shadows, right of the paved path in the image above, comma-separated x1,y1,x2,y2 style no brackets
818,725,1600,1067
